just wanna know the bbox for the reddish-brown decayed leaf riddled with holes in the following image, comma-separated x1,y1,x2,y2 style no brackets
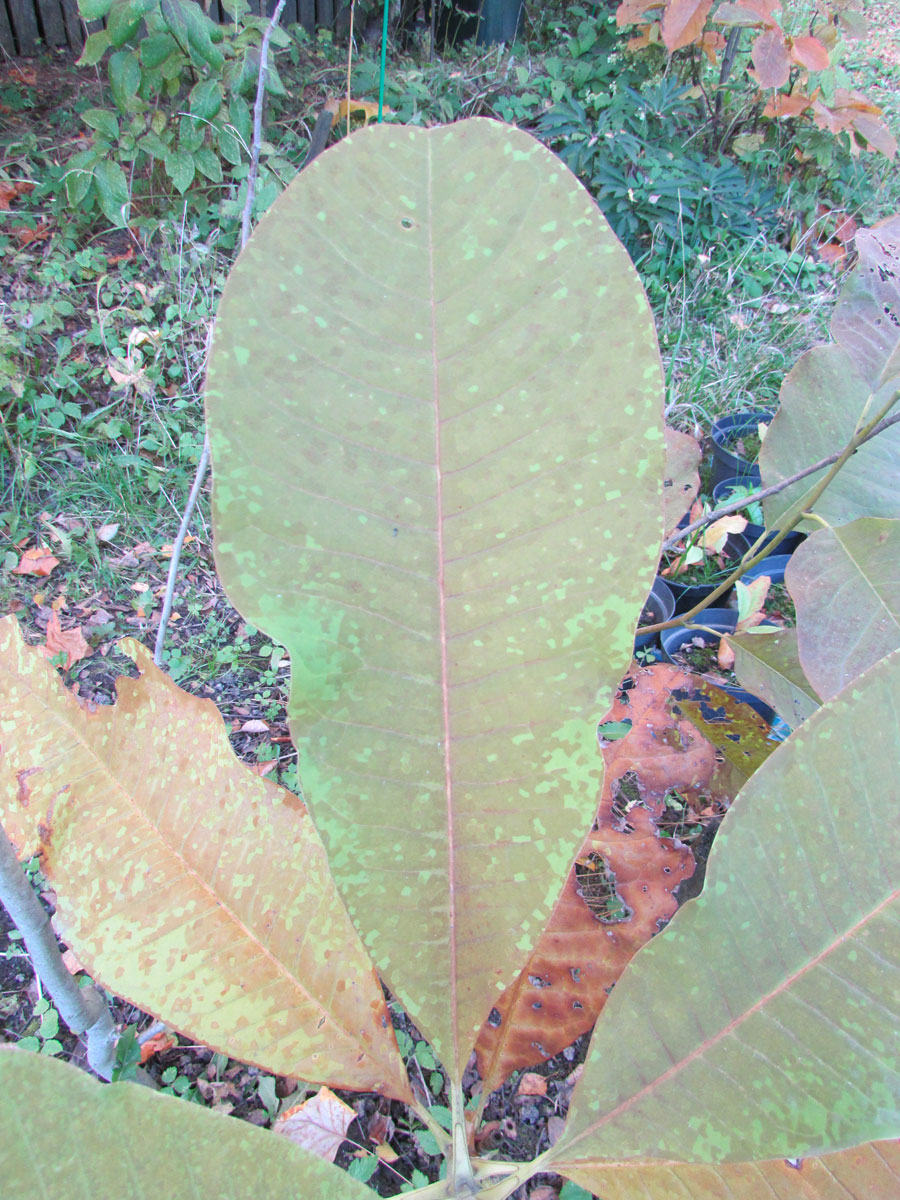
475,665,772,1094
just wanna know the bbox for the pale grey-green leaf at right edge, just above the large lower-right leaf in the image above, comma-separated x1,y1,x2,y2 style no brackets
785,517,900,700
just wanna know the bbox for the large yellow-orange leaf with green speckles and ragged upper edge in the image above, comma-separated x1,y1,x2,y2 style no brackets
0,617,412,1100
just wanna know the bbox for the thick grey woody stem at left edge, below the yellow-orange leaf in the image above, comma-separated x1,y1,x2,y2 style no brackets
0,827,116,1079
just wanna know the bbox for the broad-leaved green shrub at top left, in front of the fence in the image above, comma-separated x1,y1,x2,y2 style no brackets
70,0,292,226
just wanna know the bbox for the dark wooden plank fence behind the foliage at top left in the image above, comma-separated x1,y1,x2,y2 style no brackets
0,0,346,56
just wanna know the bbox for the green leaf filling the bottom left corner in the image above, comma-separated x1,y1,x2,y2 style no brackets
0,1048,372,1200
